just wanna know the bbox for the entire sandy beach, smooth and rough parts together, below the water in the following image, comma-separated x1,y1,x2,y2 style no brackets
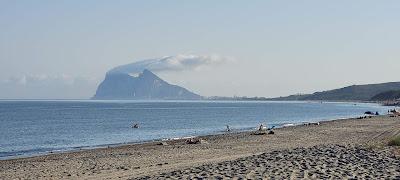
0,116,400,179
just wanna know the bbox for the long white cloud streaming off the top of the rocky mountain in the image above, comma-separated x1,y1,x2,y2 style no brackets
108,54,232,74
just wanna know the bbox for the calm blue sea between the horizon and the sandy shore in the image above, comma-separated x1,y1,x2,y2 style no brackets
0,101,388,159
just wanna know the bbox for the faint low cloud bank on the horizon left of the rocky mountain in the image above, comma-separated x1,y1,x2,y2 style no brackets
0,74,99,99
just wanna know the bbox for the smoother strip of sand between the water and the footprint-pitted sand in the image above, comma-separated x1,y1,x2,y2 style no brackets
0,116,400,179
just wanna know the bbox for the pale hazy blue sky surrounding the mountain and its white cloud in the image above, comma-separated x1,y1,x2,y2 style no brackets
0,0,400,98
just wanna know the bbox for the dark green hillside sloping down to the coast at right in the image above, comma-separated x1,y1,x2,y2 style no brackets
270,82,400,101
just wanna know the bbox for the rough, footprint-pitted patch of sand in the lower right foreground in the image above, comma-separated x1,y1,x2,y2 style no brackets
137,145,400,179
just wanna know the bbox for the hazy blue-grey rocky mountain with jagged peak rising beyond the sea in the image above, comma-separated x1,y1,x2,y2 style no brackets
92,70,202,100
